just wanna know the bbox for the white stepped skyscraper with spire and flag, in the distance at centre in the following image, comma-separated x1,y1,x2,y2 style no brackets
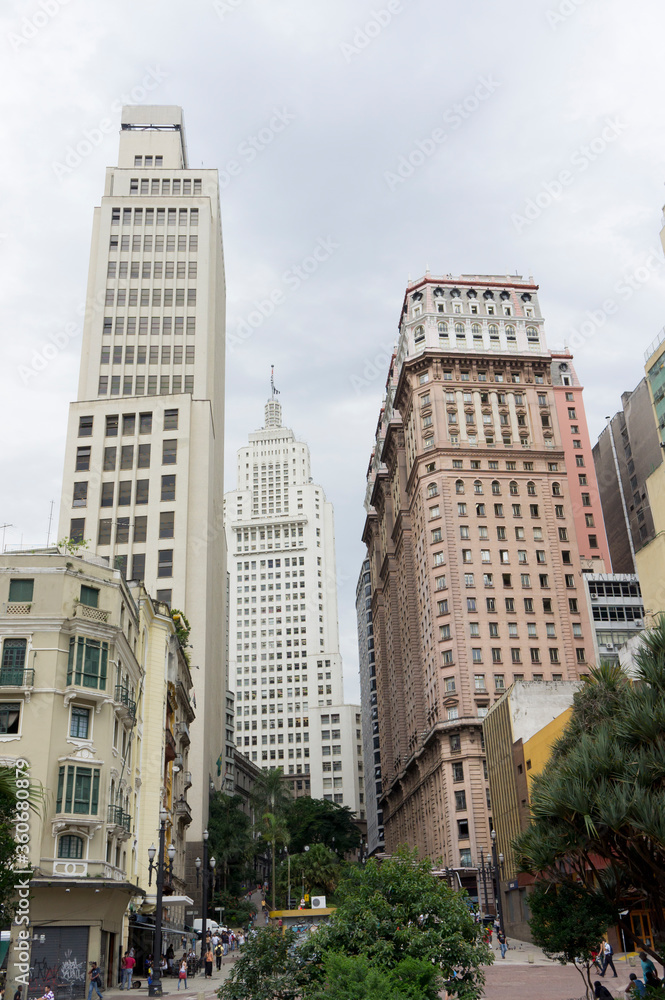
224,392,364,813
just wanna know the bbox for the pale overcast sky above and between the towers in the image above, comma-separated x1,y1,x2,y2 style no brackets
0,0,665,700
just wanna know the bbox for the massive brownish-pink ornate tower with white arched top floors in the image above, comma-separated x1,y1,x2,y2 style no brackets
364,274,593,867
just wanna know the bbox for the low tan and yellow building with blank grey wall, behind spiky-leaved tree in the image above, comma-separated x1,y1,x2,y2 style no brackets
483,681,580,941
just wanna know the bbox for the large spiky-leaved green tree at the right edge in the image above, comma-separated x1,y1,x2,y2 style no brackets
514,616,665,962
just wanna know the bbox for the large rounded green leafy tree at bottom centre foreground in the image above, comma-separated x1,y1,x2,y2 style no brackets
300,848,492,1000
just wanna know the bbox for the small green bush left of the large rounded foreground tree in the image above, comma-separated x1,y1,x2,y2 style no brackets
217,927,305,1000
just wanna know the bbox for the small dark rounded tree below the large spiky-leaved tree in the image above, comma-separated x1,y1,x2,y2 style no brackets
529,880,618,997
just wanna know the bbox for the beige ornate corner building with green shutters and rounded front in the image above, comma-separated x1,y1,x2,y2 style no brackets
0,548,194,995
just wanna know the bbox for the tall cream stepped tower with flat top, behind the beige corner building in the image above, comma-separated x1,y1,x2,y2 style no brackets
59,107,234,868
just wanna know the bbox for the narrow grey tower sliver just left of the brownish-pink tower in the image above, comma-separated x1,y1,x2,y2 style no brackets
356,559,385,856
